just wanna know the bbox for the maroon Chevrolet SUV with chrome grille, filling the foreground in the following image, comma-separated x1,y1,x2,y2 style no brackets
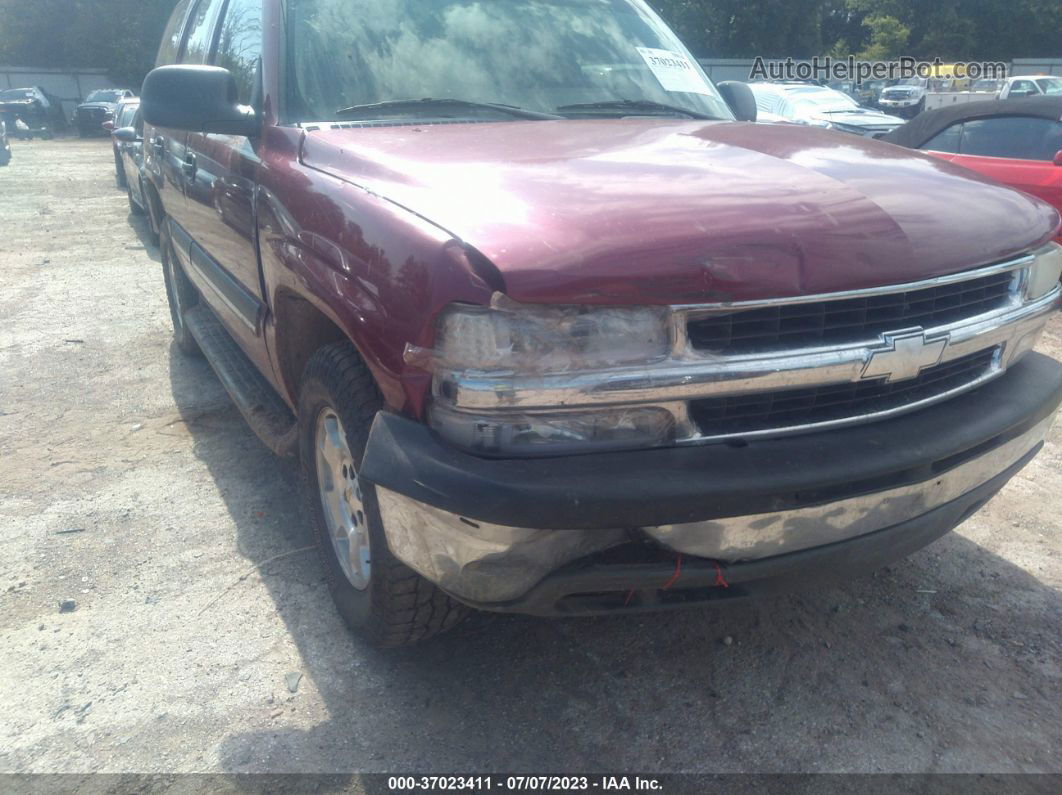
142,0,1062,644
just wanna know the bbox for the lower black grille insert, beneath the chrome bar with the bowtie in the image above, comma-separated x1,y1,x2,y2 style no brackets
689,348,996,436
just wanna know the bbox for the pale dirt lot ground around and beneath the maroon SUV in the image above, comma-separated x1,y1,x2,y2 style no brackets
0,140,1062,773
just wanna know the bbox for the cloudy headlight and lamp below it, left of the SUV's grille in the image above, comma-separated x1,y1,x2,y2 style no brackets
420,295,674,457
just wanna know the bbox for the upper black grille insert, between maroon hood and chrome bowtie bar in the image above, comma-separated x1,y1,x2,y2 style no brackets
688,266,1014,356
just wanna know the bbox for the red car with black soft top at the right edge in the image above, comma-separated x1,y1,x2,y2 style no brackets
884,97,1062,240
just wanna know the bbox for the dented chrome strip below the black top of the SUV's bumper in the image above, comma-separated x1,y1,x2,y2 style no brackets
376,416,1054,603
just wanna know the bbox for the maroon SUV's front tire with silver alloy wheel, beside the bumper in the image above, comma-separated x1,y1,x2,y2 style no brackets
298,342,468,647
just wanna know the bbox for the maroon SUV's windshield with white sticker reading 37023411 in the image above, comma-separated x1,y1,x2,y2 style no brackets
288,0,734,121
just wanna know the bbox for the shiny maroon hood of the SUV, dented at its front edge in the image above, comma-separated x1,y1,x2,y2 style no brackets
302,119,1059,304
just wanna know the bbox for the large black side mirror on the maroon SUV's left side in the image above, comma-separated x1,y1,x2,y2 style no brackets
140,65,260,138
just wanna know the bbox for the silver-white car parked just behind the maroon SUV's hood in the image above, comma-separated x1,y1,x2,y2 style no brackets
749,83,904,138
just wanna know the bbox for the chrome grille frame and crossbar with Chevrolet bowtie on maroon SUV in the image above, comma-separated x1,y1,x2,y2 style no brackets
434,260,1062,445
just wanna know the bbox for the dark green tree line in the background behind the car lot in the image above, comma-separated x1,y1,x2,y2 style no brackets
0,0,1062,88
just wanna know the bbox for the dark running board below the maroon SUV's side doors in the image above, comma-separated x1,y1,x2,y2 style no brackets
185,303,298,457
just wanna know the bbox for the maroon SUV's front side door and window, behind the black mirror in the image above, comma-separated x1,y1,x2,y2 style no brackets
174,0,269,360
